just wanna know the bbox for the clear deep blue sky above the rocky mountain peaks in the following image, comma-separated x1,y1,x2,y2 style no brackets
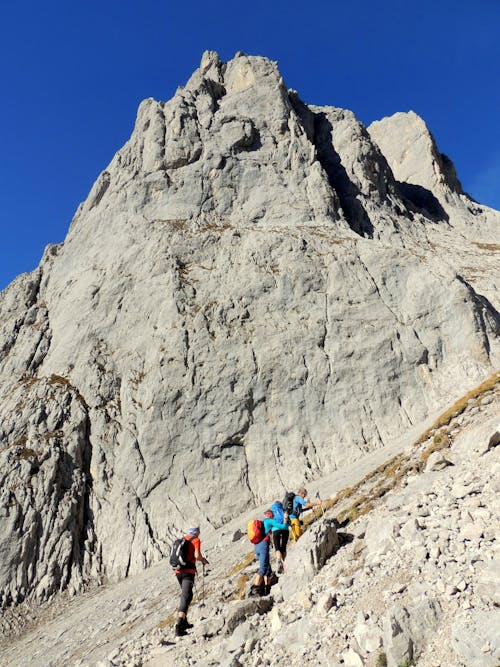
0,0,500,289
